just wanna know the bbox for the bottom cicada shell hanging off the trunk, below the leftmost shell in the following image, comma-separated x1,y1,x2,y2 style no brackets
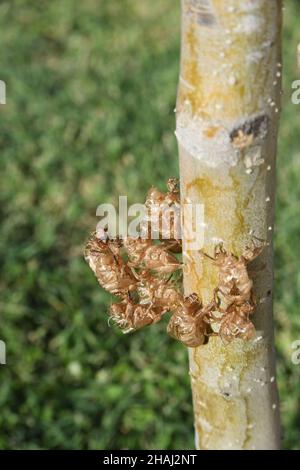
110,299,163,333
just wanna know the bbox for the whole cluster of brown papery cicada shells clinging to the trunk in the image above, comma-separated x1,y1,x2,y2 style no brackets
85,179,263,347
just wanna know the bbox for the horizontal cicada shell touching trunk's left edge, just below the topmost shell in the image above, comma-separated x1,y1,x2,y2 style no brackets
124,237,181,274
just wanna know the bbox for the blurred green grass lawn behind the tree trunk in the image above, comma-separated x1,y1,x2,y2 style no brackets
0,0,300,449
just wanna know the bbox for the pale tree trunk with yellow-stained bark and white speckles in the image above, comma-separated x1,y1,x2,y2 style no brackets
176,0,282,449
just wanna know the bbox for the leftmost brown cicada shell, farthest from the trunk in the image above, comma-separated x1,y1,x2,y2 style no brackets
85,234,137,297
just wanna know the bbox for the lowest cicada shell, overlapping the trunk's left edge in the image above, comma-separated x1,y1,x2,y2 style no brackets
167,294,215,348
